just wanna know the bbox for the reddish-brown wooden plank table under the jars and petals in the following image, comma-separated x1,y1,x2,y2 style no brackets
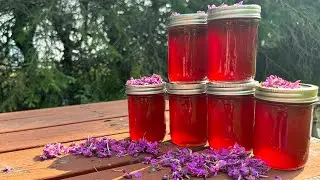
0,100,320,180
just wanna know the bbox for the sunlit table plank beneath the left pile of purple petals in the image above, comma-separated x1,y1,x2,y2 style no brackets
0,133,180,180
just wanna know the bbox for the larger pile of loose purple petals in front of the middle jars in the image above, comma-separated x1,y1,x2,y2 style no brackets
144,144,269,180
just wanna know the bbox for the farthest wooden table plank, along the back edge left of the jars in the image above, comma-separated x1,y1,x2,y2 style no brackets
0,100,168,134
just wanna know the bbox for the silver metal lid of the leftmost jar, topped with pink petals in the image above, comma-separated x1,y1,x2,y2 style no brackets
126,83,166,95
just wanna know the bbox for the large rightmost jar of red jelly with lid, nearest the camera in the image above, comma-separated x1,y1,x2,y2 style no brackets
253,84,318,170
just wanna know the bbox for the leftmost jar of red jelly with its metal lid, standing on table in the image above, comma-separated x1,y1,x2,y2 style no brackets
126,83,166,142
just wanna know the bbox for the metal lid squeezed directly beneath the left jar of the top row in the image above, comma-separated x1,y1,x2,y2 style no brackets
167,83,206,95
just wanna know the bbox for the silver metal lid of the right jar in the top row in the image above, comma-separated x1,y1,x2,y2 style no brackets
207,4,261,21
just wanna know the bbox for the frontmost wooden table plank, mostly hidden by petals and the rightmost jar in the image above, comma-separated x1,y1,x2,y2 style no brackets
68,139,320,180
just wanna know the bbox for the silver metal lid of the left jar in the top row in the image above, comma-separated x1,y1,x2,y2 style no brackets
167,13,207,27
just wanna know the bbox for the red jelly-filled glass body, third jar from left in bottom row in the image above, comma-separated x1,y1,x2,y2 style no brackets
208,95,254,151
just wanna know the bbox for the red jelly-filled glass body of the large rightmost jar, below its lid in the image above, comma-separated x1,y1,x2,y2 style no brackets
253,100,313,170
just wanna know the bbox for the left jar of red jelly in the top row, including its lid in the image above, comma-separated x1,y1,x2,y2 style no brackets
168,13,207,83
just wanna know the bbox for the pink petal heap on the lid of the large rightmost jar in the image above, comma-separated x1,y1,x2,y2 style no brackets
261,75,300,89
